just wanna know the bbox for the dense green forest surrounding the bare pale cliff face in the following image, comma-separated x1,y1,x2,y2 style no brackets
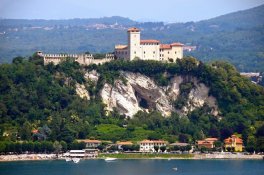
0,55,264,151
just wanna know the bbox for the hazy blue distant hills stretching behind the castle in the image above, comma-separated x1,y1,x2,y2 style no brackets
0,5,264,71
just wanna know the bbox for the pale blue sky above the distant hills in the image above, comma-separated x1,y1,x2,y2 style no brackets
0,0,264,22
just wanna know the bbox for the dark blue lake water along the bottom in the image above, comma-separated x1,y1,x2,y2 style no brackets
0,160,264,175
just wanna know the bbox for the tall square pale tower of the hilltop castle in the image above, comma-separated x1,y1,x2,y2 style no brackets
127,27,141,60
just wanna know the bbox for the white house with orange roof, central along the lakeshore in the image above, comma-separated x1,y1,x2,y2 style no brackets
139,140,167,152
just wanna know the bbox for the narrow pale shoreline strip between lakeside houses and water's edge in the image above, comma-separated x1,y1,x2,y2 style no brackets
0,154,263,162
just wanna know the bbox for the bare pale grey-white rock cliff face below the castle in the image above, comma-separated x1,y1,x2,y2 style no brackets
84,71,218,117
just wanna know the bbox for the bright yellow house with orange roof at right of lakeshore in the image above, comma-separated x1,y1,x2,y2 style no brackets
224,135,243,152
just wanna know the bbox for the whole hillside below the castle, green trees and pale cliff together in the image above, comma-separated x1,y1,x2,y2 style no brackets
0,56,264,151
